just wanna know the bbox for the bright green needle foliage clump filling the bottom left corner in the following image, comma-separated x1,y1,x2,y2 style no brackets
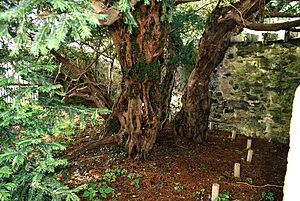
0,131,84,201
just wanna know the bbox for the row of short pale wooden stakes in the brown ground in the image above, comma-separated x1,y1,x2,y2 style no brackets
211,130,253,201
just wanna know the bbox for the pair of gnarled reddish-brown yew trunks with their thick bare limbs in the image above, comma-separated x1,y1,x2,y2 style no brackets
54,0,299,158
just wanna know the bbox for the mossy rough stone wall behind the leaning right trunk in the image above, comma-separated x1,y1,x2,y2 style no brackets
210,40,300,142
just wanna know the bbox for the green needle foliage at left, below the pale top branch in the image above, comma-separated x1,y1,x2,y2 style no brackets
0,56,109,201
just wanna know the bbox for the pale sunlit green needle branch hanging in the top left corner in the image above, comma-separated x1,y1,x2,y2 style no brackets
0,0,104,55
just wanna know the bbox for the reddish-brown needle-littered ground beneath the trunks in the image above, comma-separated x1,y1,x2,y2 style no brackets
59,131,288,201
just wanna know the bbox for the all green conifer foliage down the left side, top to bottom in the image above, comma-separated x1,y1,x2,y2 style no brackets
0,0,108,198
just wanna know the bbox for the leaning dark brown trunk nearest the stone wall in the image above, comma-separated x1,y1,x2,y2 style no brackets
175,0,259,143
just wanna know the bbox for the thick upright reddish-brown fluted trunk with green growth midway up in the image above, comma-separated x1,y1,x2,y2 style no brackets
110,0,166,158
